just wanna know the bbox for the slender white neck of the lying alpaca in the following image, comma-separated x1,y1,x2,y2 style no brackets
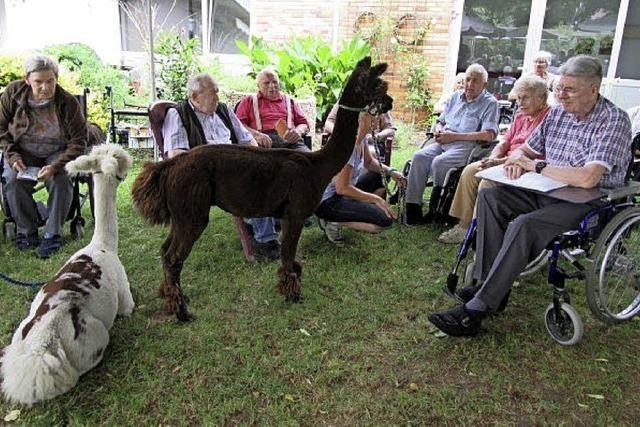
91,174,118,252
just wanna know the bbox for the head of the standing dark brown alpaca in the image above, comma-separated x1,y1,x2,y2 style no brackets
340,56,393,114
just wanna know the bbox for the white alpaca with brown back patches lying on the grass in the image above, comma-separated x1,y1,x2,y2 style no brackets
0,145,134,405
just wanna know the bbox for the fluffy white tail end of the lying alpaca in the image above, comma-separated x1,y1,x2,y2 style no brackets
0,341,80,405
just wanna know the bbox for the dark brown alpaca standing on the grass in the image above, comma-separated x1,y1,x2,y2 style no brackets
132,58,392,321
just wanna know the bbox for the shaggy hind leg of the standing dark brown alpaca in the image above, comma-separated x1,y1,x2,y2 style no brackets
161,222,207,322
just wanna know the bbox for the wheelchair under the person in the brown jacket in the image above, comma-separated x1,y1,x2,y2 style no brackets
0,89,100,241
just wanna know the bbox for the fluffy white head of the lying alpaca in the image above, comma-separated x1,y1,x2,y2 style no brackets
66,144,132,180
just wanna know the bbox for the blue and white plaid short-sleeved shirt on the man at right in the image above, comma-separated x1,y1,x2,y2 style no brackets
526,96,631,188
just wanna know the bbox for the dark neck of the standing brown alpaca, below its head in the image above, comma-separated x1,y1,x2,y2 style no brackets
319,108,360,182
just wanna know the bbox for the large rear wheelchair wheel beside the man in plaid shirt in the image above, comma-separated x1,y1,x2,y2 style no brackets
586,207,640,324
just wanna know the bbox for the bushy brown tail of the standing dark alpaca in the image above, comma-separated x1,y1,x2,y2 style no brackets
131,161,173,225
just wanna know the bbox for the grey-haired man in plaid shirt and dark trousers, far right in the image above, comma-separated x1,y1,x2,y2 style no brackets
429,55,631,336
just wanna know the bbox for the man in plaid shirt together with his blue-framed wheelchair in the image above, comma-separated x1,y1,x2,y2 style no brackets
429,55,640,344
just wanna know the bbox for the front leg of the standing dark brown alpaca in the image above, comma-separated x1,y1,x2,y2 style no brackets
278,219,303,302
